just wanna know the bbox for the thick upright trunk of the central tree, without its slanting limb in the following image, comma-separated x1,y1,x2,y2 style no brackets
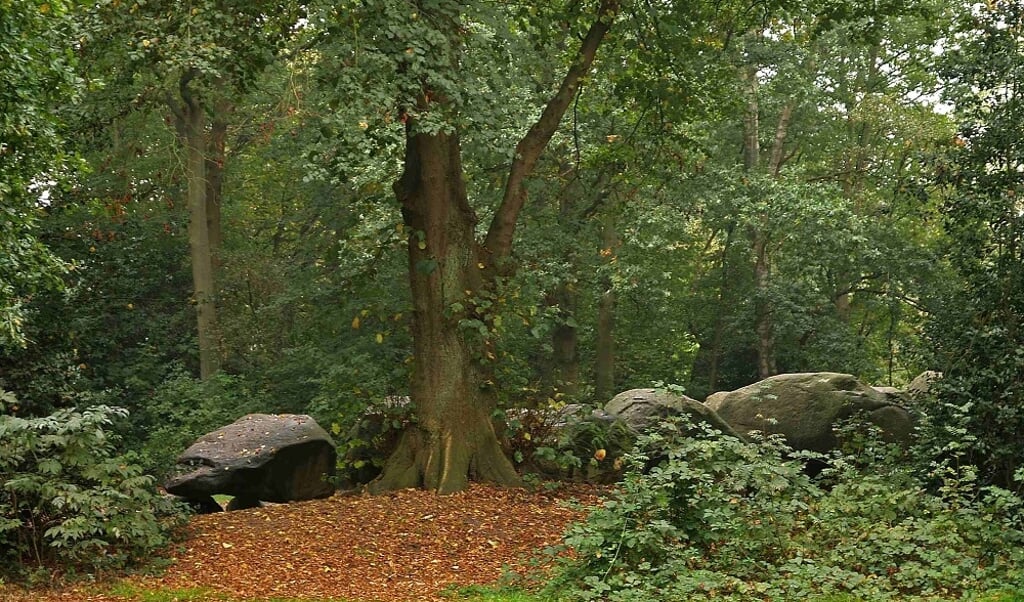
371,126,520,493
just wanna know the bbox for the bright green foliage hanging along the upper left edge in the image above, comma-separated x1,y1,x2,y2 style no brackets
0,0,78,348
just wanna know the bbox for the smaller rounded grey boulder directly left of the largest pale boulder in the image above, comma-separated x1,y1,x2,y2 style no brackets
604,389,741,438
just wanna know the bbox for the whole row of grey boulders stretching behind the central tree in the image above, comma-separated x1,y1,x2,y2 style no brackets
165,373,937,511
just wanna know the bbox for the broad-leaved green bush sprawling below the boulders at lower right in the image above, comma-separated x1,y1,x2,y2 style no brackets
548,415,1024,601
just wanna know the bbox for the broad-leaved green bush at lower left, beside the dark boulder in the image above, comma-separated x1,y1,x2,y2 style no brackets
0,391,183,577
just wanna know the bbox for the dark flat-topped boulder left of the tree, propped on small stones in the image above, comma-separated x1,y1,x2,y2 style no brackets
165,414,336,509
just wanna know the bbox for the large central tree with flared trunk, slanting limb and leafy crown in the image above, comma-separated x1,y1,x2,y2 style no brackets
311,0,790,491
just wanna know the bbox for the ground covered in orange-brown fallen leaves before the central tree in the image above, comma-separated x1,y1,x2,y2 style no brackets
0,484,597,602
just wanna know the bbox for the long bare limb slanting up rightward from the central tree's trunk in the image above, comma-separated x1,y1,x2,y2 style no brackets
484,0,620,266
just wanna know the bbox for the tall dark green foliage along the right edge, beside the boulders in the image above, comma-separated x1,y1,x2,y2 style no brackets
929,2,1024,487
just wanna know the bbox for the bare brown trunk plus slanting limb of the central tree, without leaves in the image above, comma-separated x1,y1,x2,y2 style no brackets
369,0,618,493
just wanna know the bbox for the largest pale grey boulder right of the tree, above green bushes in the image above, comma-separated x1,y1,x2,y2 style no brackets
707,372,913,453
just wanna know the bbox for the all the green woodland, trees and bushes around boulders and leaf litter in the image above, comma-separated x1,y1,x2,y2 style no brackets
0,0,1024,601
